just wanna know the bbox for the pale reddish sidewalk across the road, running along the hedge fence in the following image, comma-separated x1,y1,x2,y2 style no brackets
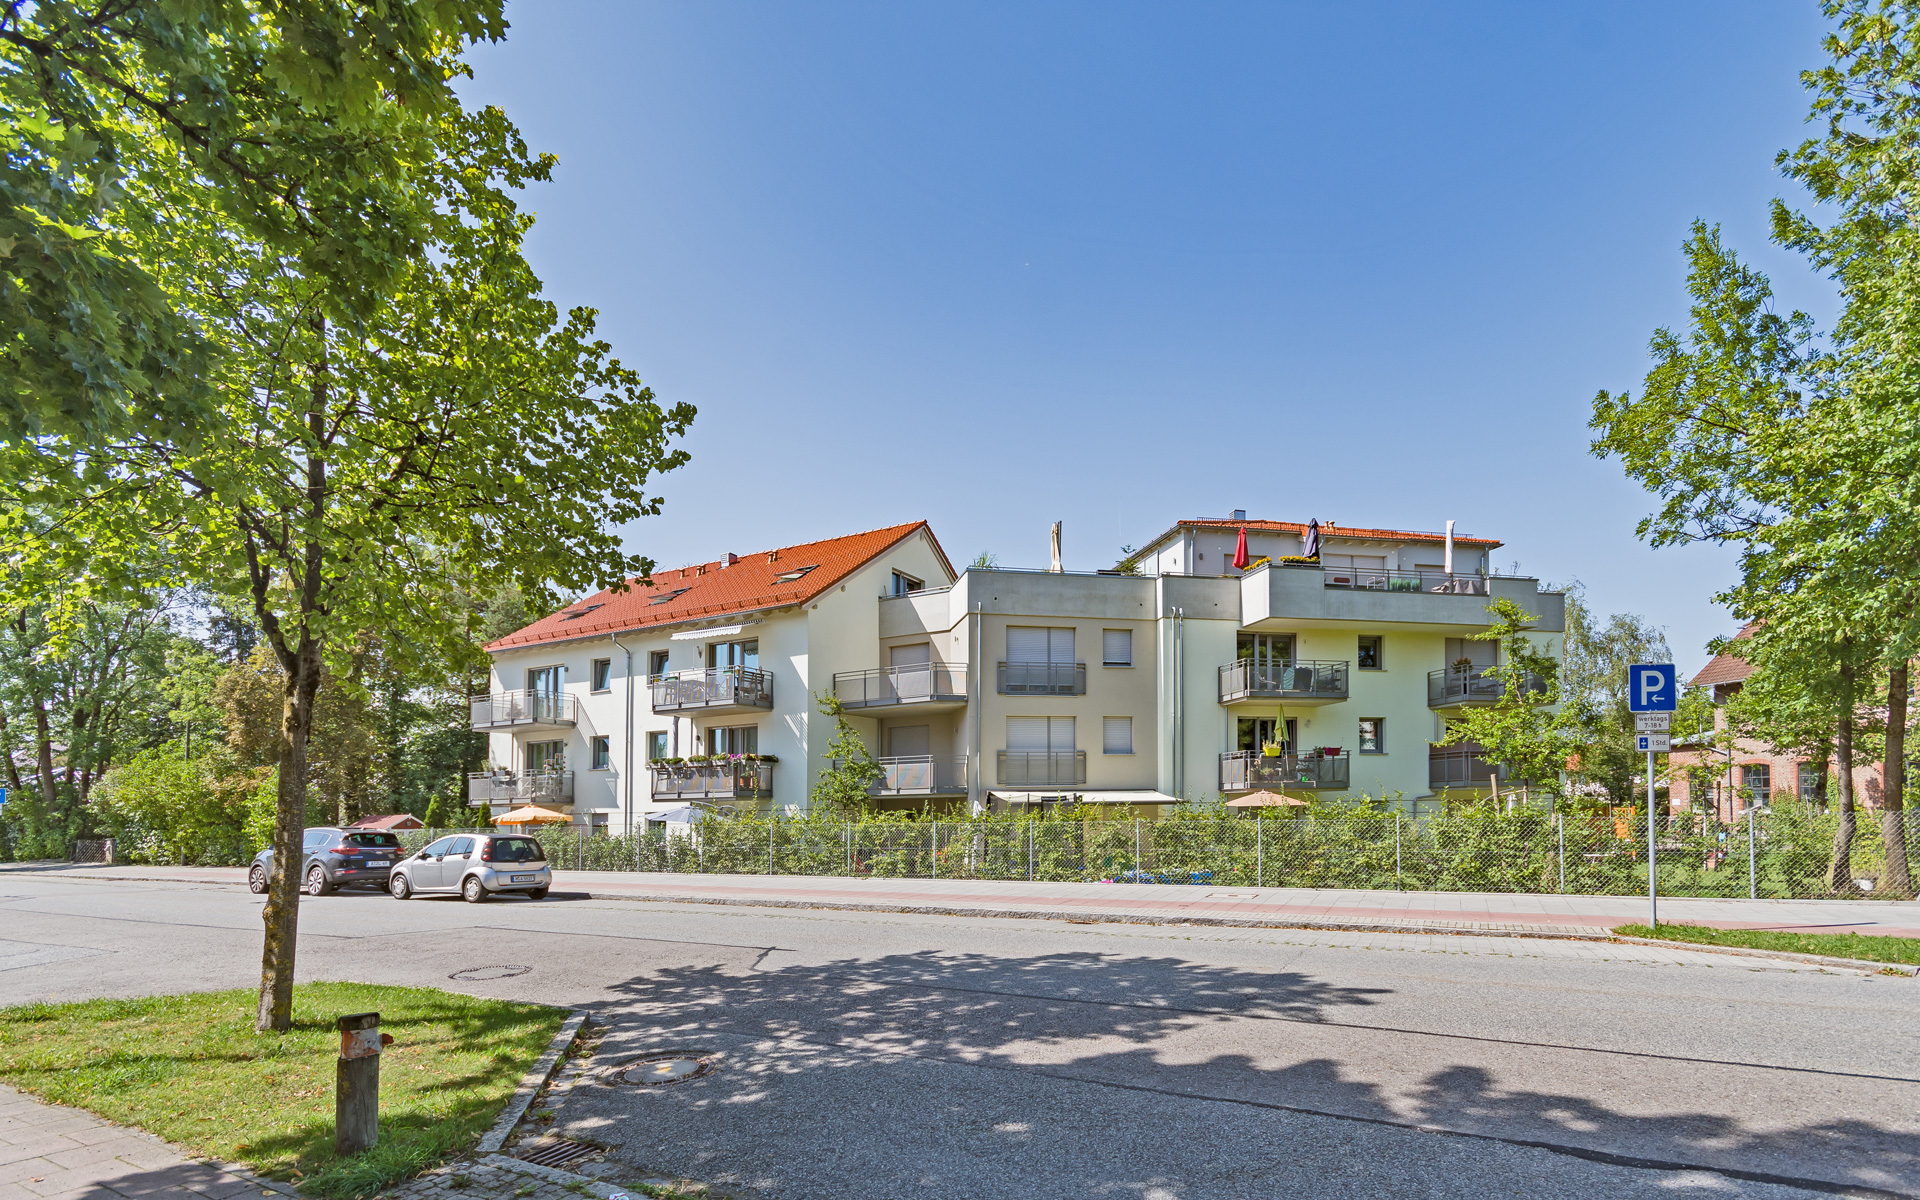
18,864,1920,937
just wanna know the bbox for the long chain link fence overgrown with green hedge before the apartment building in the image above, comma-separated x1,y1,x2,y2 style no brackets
399,804,1920,899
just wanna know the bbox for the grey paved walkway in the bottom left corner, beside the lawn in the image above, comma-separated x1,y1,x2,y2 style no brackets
0,1085,296,1200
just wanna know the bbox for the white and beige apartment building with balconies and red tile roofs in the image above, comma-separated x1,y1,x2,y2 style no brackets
468,513,1565,831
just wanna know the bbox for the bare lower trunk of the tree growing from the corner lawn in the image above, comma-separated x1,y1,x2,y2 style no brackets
253,636,321,1033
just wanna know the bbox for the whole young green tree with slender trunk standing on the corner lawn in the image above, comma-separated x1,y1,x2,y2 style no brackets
0,104,693,1029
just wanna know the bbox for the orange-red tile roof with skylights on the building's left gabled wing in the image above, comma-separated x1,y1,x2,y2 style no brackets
486,520,954,651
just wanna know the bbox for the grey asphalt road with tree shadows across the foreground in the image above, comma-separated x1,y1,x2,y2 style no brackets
0,870,1920,1200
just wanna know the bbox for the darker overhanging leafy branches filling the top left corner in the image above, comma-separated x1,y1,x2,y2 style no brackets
0,0,507,442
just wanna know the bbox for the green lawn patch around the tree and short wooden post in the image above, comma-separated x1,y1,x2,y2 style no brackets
0,983,566,1198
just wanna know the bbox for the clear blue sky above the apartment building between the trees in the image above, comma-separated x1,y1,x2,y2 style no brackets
456,0,1828,670
